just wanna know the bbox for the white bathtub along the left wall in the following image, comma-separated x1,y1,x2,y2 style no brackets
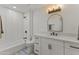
0,40,25,55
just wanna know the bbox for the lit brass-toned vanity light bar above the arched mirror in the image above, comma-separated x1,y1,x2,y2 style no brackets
47,4,62,14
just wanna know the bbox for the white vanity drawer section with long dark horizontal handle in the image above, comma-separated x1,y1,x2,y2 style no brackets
65,43,79,55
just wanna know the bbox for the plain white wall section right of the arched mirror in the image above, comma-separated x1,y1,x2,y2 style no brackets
62,4,79,34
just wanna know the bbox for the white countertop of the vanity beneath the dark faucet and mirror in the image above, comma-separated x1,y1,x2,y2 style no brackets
34,34,79,43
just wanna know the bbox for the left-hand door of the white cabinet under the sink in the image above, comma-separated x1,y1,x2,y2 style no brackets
40,38,50,55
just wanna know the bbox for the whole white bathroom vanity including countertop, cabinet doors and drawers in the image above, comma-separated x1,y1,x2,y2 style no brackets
33,34,79,55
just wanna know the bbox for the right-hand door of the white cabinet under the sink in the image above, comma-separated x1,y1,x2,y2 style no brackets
50,39,64,55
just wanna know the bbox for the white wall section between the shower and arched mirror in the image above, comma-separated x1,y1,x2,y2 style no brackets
33,9,48,34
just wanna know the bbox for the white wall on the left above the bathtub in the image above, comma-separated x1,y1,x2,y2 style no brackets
0,7,23,50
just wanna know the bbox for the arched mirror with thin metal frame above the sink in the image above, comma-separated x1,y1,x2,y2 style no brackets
47,14,63,32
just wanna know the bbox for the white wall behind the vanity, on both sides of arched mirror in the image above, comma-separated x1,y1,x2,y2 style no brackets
33,5,79,34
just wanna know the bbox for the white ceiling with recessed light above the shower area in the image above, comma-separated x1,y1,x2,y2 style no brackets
0,4,45,13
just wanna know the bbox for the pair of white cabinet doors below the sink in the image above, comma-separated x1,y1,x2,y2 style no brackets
40,38,64,55
